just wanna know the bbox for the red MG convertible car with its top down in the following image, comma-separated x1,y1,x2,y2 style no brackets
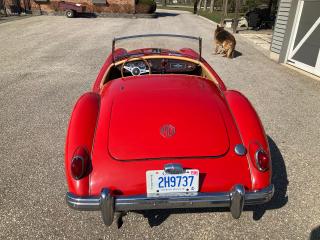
65,34,274,226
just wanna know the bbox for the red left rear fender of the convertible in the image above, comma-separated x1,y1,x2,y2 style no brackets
65,92,100,196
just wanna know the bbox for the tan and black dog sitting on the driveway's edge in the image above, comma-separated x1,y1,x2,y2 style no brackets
214,25,236,58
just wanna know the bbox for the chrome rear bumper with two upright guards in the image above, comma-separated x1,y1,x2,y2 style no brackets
66,184,274,226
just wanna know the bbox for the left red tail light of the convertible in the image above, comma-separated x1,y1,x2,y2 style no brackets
71,148,90,180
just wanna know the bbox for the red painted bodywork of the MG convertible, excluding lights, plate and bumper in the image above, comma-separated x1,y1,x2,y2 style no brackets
65,45,271,202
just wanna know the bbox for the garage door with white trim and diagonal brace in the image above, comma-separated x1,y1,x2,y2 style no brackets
287,0,320,76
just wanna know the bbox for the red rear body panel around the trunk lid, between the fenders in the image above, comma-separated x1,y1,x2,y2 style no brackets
85,75,252,195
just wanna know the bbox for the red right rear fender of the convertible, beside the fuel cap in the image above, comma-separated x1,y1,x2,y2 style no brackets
225,90,272,190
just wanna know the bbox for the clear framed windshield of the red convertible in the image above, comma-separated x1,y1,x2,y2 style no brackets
112,34,202,61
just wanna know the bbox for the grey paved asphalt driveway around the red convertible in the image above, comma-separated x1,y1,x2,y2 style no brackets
0,8,320,239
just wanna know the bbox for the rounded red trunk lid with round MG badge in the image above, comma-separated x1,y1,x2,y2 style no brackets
108,77,229,160
